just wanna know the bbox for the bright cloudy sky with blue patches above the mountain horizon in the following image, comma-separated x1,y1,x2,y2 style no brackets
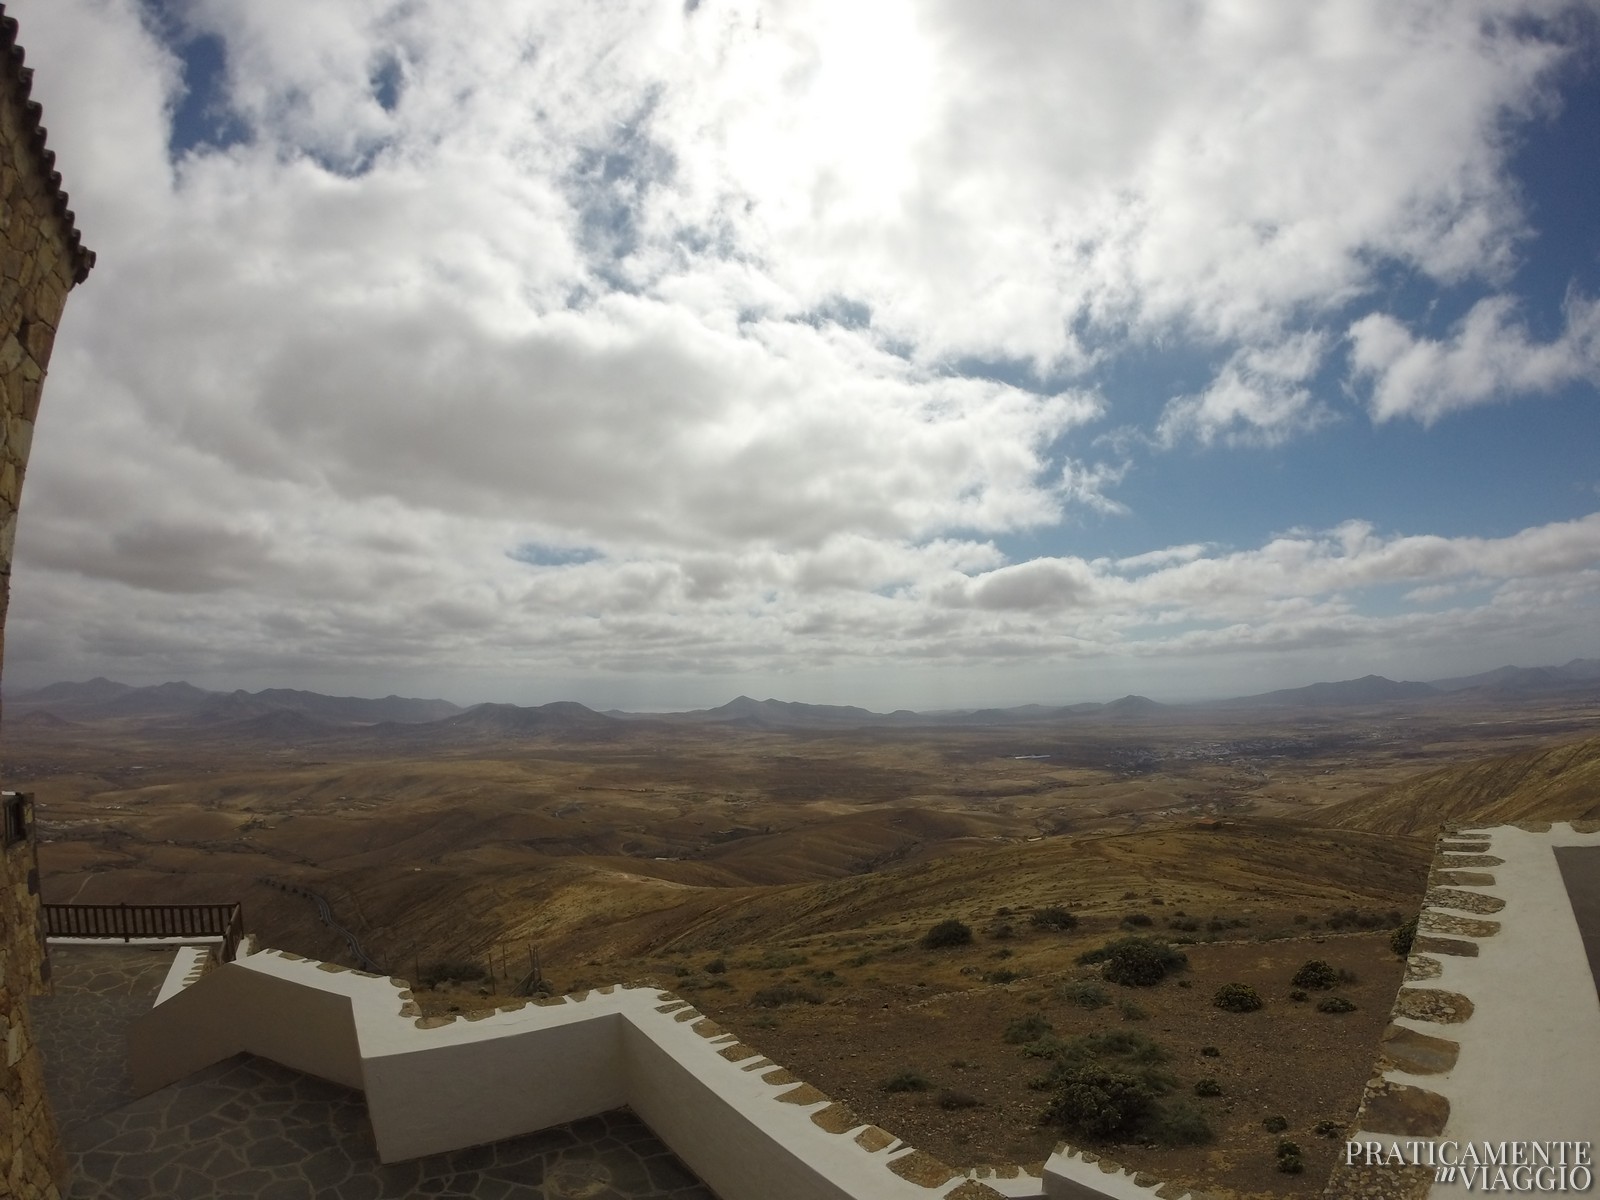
5,0,1600,709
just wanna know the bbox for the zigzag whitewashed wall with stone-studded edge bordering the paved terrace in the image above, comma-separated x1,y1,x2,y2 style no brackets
131,950,1198,1200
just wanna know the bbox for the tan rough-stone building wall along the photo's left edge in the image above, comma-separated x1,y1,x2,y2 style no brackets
0,5,94,1200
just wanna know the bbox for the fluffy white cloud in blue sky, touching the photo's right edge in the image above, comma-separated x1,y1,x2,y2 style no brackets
1350,296,1600,426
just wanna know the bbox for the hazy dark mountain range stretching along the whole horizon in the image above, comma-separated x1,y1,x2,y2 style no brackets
5,659,1600,744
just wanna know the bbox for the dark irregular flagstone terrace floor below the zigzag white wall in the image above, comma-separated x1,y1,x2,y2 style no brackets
23,946,715,1200
